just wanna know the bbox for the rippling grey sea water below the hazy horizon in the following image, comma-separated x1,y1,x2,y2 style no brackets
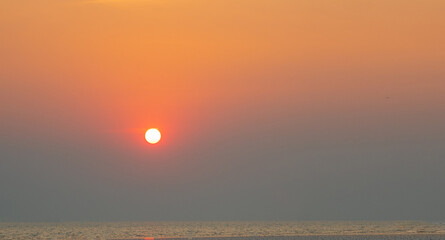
0,222,445,240
